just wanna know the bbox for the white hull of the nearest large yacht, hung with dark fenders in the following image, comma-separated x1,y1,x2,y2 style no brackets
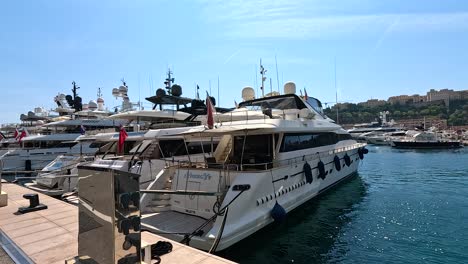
142,149,360,251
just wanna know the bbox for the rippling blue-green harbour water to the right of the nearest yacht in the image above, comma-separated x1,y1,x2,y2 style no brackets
220,147,468,263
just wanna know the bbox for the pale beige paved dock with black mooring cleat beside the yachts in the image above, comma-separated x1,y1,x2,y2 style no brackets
0,183,234,264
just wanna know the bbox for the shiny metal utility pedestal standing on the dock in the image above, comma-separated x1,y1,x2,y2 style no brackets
67,160,141,264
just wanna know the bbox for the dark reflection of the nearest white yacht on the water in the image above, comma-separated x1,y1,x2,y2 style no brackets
219,175,367,263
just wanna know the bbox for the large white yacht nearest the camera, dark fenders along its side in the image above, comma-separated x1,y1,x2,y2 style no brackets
140,82,367,252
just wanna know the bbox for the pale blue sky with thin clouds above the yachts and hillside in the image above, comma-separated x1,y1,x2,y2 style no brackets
0,0,468,123
